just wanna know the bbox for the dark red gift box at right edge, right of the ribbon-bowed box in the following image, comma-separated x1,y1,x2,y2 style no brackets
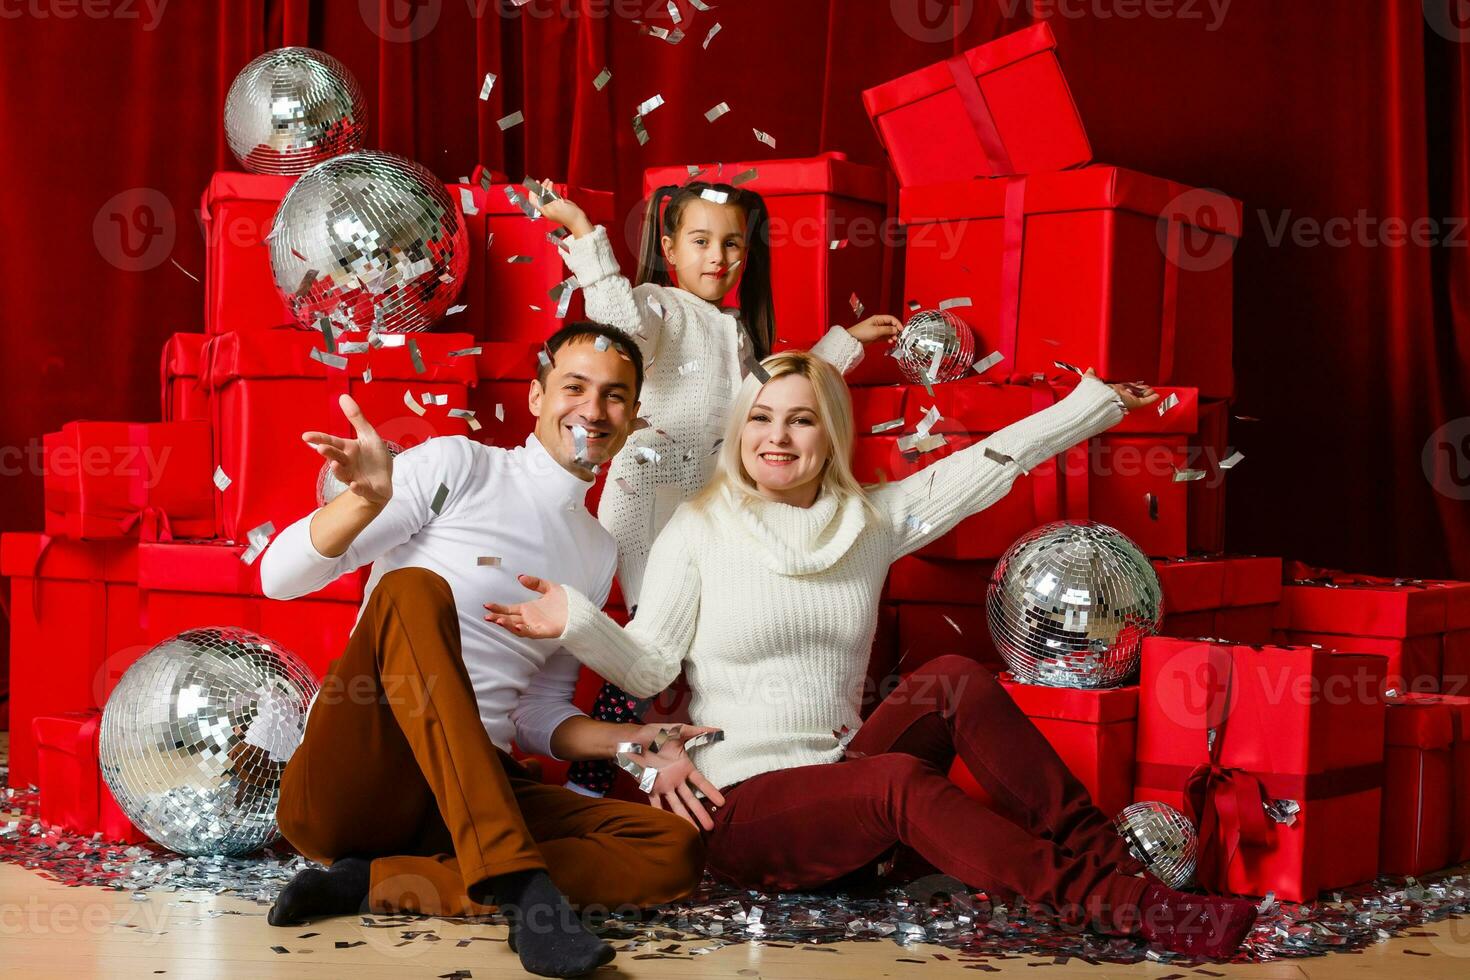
1379,695,1470,876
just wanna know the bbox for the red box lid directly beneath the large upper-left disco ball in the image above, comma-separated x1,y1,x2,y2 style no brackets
203,329,478,388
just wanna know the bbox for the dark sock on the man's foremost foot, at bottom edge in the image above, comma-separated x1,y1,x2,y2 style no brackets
487,868,614,977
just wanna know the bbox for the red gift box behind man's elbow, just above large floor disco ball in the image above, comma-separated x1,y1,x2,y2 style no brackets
138,542,369,681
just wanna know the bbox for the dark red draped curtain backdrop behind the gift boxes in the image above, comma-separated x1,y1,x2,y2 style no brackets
0,0,1470,587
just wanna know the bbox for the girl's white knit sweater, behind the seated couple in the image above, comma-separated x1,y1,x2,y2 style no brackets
564,225,863,608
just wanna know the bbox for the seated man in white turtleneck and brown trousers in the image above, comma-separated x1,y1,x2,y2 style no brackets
260,323,723,976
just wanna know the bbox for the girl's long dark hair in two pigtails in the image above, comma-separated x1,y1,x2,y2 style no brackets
635,181,776,360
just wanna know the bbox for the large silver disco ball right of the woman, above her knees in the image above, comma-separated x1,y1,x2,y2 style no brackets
985,522,1163,688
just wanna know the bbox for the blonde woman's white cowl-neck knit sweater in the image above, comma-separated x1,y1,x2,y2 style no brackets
562,378,1125,788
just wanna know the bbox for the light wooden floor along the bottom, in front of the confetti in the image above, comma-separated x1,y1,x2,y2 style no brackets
0,733,1470,980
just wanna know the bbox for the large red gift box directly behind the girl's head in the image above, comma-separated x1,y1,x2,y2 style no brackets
646,153,897,357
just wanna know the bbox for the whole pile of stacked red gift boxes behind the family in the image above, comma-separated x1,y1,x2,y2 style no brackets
0,25,1470,899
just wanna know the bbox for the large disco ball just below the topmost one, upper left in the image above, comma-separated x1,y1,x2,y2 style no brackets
266,151,469,334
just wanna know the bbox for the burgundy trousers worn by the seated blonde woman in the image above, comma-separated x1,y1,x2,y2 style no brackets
707,655,1145,933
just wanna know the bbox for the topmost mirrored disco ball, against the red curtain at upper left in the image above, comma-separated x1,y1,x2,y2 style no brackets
225,47,368,173
